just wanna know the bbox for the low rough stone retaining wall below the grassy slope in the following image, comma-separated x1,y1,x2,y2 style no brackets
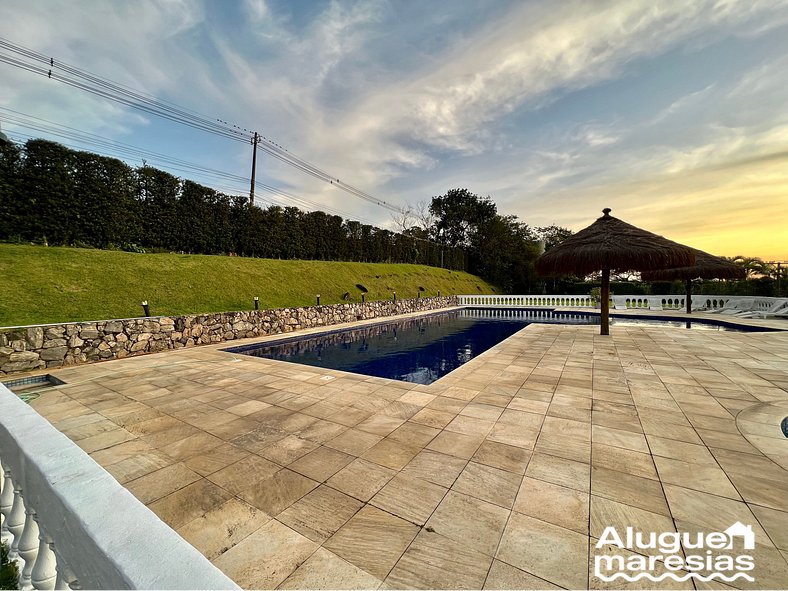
0,296,457,376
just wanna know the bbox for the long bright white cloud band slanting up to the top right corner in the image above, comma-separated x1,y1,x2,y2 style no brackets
346,2,788,151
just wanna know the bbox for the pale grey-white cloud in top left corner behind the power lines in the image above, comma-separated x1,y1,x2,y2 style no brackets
0,1,208,134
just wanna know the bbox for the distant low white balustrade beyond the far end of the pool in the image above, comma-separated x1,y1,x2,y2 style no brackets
457,295,756,310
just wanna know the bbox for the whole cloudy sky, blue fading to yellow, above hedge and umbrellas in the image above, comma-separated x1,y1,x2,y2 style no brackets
0,0,788,261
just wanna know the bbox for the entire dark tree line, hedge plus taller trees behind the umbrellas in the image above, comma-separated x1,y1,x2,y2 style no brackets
6,139,772,295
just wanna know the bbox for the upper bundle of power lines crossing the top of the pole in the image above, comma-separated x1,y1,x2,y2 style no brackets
0,37,402,213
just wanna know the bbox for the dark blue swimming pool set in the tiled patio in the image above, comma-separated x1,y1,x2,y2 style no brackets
224,308,772,384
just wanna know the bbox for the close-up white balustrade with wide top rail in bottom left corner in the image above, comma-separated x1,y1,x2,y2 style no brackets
0,384,239,589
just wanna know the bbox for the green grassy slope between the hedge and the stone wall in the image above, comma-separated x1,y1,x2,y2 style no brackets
0,244,493,326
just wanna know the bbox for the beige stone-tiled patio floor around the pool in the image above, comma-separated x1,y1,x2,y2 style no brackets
27,312,788,589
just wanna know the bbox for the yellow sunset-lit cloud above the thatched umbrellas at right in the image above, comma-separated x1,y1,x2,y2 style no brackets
516,118,788,260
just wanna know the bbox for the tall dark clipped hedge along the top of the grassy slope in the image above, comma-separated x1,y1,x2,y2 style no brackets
0,139,468,270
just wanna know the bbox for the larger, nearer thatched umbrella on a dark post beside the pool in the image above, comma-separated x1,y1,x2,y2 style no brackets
536,208,695,335
